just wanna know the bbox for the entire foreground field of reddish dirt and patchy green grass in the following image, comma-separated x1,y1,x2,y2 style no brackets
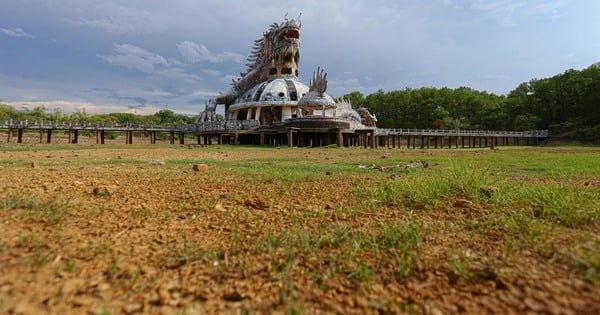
0,144,600,314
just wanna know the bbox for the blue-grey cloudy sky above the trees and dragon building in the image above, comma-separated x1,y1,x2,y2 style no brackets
0,0,600,115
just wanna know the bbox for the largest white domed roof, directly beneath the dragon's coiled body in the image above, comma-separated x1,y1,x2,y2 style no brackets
235,75,308,104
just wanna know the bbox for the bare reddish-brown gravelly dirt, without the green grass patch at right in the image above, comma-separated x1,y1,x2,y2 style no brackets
0,146,600,314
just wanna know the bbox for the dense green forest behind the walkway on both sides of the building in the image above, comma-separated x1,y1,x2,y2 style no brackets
0,63,600,141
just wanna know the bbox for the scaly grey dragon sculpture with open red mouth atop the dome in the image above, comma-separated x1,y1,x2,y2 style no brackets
196,14,301,123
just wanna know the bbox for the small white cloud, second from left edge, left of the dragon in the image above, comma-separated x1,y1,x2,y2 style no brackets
97,44,169,73
